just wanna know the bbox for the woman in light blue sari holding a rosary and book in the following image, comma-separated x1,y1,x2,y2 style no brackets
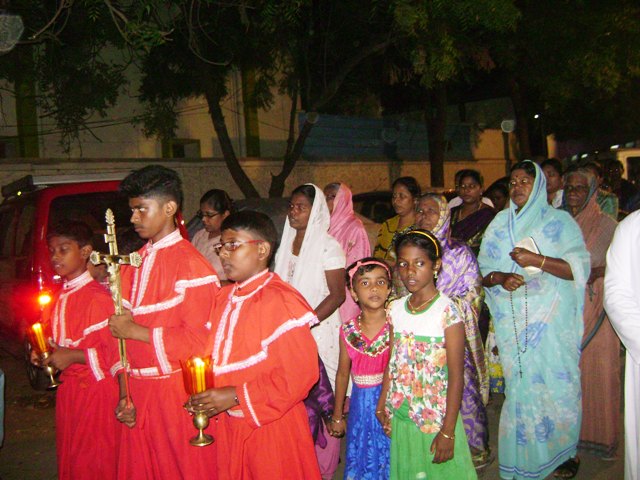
478,160,590,480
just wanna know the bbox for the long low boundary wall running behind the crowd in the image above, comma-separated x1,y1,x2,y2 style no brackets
0,158,504,218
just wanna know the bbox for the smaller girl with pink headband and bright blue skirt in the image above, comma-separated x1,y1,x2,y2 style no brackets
330,257,391,480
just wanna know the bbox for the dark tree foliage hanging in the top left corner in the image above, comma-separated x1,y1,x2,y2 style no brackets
0,0,126,151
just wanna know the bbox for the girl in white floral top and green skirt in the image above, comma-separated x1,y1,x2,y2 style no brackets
376,230,477,480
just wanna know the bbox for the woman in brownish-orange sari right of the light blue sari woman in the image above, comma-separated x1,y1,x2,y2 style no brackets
563,168,621,459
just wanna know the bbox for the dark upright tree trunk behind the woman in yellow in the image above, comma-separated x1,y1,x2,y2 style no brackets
424,83,447,187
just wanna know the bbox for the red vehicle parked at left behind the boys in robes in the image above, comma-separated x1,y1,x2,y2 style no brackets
0,174,130,389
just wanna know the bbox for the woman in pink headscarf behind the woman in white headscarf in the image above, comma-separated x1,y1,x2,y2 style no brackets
324,183,371,322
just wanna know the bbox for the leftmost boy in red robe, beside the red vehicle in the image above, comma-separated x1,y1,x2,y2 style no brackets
37,221,119,480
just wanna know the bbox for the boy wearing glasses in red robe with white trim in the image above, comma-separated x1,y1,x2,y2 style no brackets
188,211,320,479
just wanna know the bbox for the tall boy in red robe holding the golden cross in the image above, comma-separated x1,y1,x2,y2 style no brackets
109,165,219,480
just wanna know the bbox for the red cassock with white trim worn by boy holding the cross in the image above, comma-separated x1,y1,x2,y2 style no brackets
114,230,219,480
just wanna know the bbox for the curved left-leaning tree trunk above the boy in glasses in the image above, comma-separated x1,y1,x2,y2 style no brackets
205,85,260,198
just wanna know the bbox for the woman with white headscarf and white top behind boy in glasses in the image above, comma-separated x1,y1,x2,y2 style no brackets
274,183,346,478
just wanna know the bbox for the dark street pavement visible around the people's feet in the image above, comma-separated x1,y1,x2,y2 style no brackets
0,338,624,480
